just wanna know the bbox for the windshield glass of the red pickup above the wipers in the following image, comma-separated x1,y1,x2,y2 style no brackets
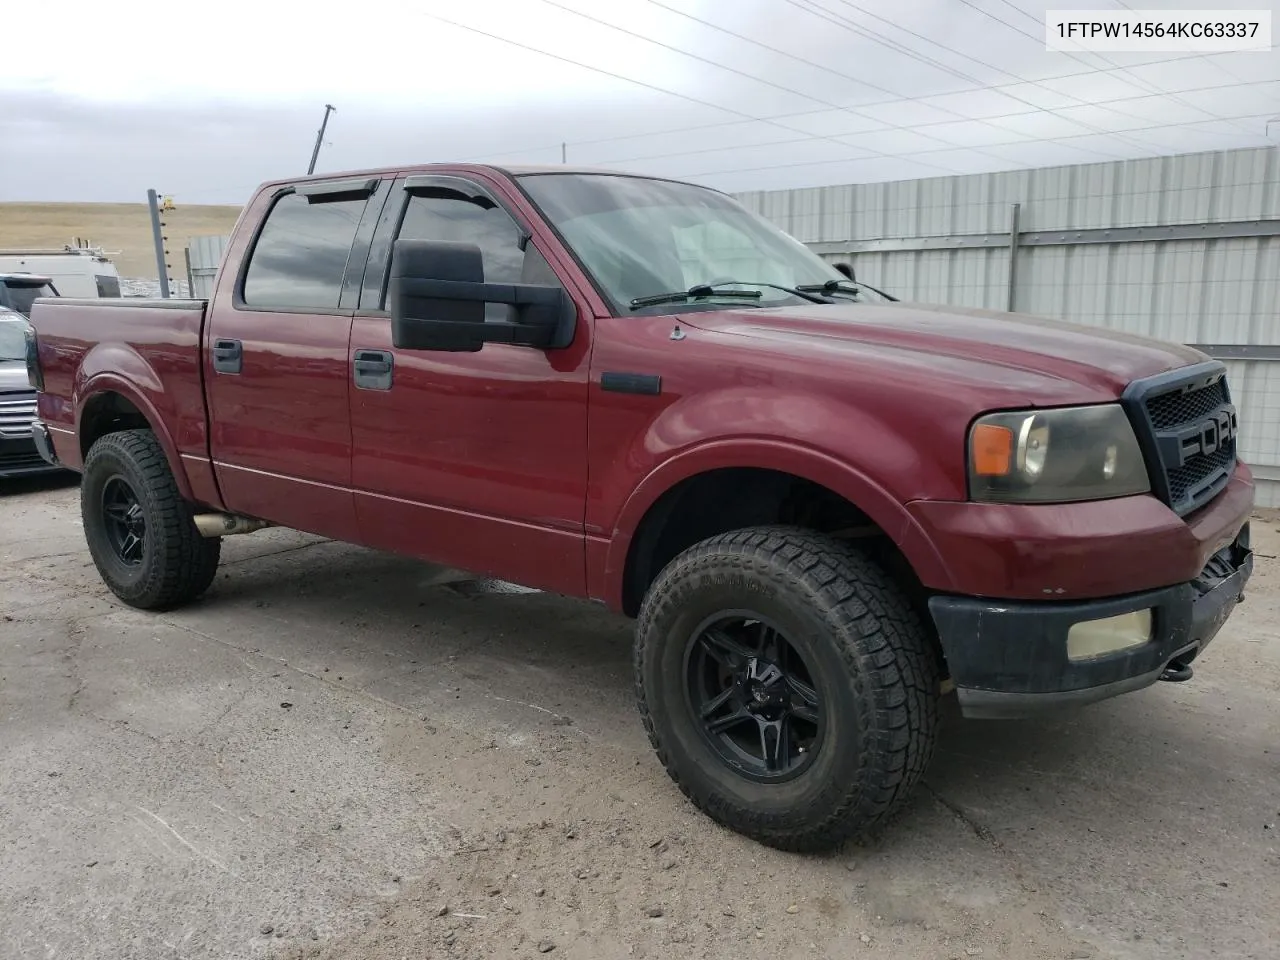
520,174,851,314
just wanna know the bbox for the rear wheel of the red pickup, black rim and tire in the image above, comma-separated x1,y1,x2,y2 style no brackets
81,430,221,609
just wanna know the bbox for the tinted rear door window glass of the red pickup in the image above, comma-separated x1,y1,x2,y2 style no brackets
243,193,366,310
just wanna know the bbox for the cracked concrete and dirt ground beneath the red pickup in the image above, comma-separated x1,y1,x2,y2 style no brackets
0,481,1280,960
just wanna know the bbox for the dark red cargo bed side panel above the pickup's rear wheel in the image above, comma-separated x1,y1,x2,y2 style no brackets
31,297,209,481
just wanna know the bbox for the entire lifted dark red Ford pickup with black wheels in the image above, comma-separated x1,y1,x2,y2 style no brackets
27,165,1253,850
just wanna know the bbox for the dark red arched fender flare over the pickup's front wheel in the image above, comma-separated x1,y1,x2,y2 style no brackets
593,436,951,608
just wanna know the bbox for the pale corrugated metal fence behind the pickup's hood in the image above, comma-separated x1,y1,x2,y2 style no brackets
739,147,1280,506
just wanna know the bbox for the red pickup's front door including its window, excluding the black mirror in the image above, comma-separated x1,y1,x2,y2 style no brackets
349,177,590,594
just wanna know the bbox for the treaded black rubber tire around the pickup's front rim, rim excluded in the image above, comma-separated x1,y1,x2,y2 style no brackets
635,527,941,851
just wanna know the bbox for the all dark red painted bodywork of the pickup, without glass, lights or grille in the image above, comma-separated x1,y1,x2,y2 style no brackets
24,166,1253,616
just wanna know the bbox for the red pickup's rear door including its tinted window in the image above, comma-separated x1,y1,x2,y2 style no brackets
204,178,387,540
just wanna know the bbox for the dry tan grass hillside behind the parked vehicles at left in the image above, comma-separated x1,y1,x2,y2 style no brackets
0,204,241,279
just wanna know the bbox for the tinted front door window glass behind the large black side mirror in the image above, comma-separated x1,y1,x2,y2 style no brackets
386,188,557,320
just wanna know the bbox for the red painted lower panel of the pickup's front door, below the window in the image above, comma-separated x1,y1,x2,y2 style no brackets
351,317,590,594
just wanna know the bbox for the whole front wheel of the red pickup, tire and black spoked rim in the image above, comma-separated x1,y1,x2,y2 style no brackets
635,527,940,851
